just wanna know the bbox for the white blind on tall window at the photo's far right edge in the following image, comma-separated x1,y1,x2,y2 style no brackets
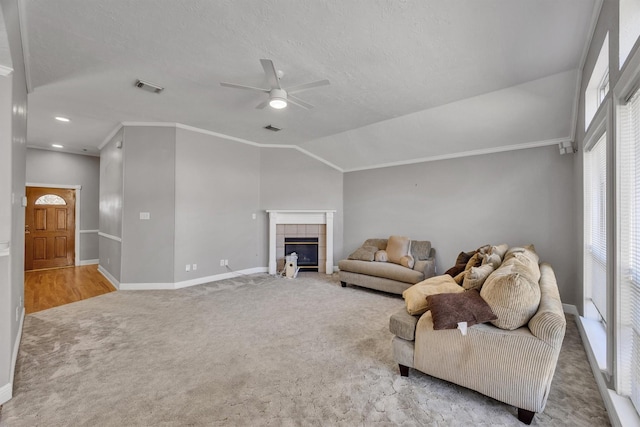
617,87,640,412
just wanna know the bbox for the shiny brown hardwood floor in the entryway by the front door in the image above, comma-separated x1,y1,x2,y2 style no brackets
24,265,116,314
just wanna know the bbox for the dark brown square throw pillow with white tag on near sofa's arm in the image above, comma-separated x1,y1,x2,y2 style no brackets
427,289,498,330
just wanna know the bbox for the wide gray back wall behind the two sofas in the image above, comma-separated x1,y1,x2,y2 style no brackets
344,146,579,304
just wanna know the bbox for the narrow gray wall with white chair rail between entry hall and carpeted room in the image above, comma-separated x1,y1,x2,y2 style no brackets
98,129,124,281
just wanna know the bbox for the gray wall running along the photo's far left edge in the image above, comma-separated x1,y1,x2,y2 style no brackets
0,0,27,402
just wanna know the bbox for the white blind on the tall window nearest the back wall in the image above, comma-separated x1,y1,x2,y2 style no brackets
585,134,607,322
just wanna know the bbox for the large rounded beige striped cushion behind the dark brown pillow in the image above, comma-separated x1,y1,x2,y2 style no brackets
480,266,540,330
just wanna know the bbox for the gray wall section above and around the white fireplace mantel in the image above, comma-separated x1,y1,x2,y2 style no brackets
259,148,344,265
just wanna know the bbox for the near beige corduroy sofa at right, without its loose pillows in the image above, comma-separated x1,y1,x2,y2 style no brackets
389,244,566,424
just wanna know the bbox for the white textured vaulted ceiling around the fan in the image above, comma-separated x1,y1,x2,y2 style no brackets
20,0,598,170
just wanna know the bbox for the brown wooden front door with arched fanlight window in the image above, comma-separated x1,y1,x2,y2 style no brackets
24,187,76,270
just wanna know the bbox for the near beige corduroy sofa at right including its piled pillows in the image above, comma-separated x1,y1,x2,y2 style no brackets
389,245,566,424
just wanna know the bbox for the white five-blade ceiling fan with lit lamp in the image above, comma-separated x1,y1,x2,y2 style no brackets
220,59,329,110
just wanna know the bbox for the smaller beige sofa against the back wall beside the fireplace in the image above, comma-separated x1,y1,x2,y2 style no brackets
338,236,436,294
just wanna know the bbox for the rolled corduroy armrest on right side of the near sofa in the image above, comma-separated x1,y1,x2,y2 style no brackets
529,263,567,348
